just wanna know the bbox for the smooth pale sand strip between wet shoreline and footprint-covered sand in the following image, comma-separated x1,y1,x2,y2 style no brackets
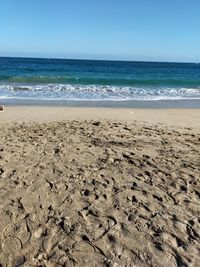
0,106,200,132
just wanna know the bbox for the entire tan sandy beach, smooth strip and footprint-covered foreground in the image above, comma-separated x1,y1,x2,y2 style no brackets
0,107,200,267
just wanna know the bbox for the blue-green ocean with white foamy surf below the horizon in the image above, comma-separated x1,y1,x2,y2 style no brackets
0,57,200,106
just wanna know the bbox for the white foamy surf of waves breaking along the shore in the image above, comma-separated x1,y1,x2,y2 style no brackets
0,84,200,101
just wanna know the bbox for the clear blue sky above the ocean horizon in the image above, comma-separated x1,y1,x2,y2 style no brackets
0,0,200,62
